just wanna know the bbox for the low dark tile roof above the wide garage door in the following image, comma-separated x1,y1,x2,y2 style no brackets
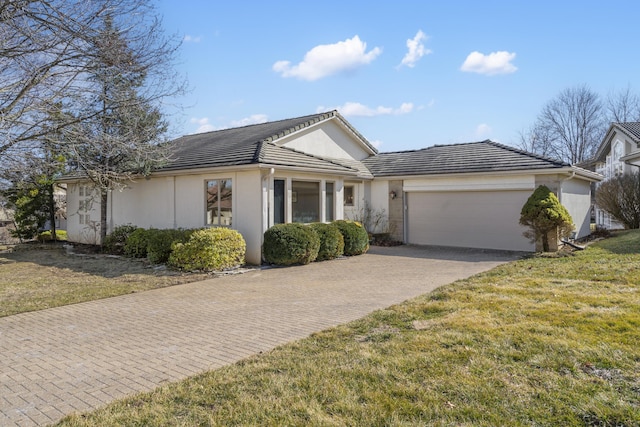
364,140,570,176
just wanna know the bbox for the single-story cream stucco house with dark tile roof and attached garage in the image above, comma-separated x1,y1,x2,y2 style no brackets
60,111,600,264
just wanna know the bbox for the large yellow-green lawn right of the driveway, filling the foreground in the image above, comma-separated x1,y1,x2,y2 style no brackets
60,231,640,426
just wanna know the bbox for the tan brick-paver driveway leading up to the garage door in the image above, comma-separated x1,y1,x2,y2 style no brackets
0,246,517,426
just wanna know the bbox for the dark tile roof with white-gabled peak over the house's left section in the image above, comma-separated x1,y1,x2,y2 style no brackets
162,111,376,173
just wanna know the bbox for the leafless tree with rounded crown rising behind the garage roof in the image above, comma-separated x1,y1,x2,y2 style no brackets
521,85,606,164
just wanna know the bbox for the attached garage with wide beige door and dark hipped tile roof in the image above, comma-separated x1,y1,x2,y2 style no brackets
364,141,601,252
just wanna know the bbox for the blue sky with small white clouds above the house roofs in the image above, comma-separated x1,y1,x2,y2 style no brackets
158,0,640,152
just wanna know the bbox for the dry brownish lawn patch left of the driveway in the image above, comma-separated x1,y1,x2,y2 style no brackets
0,244,207,317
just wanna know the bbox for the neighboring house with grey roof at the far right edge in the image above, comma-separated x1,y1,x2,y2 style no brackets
594,122,640,229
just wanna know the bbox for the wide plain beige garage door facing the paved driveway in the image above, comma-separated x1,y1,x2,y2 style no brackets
407,191,534,251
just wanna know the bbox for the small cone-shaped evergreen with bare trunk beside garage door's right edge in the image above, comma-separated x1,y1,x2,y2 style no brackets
520,185,574,252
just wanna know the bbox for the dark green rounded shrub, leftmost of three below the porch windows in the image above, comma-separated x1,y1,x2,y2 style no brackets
262,223,320,265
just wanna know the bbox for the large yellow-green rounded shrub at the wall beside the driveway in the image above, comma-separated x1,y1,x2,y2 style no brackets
168,227,247,271
